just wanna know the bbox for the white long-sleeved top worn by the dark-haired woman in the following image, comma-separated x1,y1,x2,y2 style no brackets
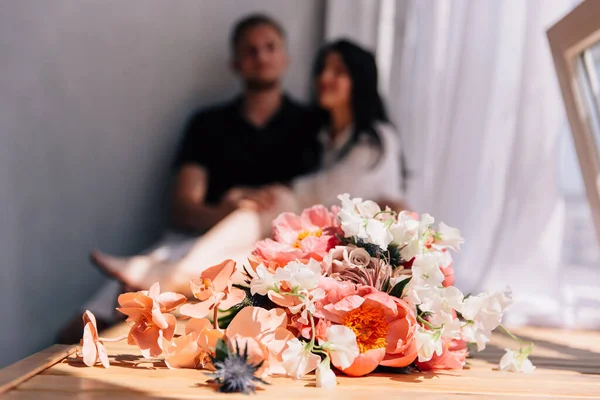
292,123,403,208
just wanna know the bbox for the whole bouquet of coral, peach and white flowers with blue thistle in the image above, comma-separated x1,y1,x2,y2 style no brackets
82,194,534,392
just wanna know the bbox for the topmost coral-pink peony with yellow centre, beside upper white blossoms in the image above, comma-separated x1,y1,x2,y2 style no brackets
253,205,340,267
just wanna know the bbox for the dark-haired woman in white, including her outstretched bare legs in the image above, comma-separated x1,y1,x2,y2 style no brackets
94,40,406,294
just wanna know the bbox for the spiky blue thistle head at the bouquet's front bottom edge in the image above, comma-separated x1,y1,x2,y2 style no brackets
211,339,268,394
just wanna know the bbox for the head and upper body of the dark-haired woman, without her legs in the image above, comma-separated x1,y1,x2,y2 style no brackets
293,40,406,210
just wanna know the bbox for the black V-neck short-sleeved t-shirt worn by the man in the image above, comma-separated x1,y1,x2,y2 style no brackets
177,96,318,203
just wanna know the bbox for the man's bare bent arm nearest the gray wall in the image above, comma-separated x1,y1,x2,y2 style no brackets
173,163,235,232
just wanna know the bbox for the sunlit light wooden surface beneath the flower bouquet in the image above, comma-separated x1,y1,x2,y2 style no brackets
0,326,600,400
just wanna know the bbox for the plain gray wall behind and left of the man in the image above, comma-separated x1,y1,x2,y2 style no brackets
0,0,324,367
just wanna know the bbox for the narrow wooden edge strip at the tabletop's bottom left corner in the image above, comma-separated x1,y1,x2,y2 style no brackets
0,344,78,394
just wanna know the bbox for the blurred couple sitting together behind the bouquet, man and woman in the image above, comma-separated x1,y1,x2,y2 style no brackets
60,14,407,342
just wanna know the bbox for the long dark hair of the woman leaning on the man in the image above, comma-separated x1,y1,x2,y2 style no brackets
312,39,407,186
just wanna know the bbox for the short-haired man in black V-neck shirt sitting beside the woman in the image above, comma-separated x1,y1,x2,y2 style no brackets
58,15,317,343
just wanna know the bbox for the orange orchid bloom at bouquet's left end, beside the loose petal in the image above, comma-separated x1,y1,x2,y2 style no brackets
117,282,186,358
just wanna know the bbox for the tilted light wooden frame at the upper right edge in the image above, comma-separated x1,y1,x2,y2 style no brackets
547,0,600,242
